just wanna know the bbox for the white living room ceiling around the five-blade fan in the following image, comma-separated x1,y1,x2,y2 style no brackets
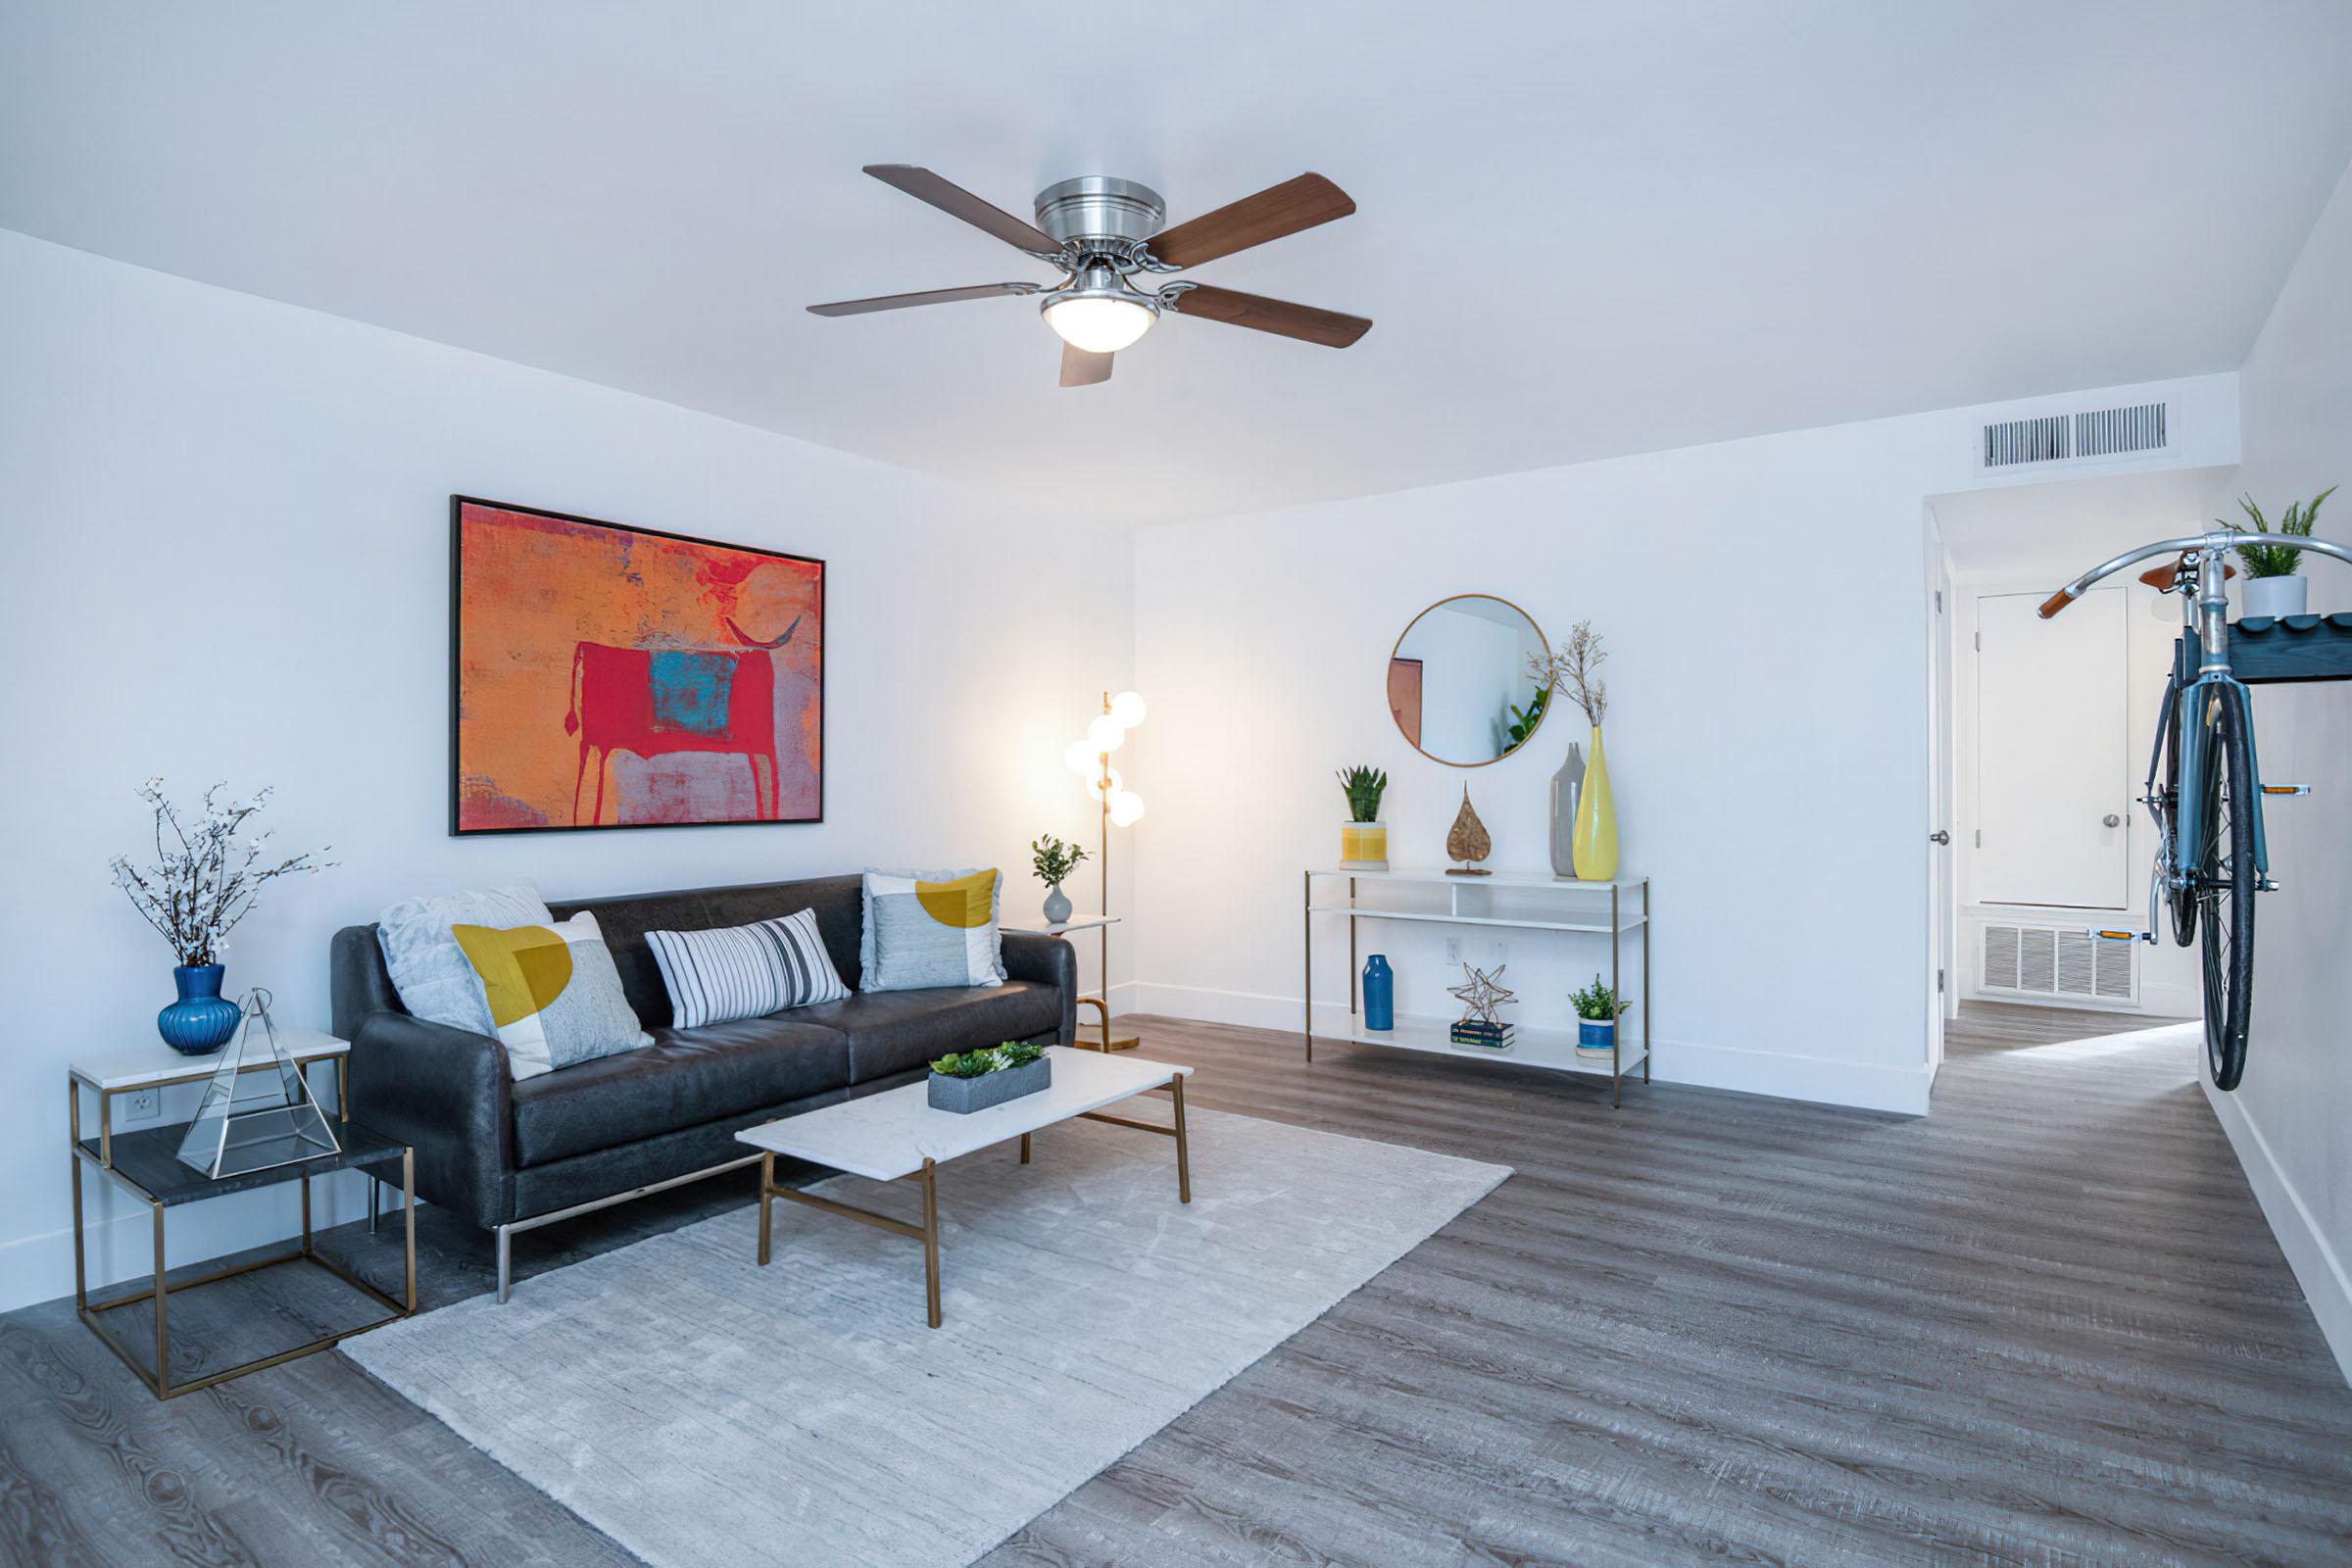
0,0,2352,522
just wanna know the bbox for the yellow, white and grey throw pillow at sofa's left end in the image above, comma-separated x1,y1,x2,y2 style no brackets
449,912,654,1079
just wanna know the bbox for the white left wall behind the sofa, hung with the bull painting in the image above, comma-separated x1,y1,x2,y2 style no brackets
0,232,1129,1309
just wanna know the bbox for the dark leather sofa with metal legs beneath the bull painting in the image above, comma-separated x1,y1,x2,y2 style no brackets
331,877,1077,1300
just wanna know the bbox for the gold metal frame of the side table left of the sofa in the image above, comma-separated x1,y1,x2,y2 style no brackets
66,1072,416,1398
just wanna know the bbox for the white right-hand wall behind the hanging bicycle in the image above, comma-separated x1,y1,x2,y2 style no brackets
2209,162,2352,1378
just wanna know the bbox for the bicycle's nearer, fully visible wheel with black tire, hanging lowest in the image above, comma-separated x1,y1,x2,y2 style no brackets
2197,684,2260,1089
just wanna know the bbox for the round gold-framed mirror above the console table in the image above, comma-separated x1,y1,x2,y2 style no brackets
1388,592,1550,768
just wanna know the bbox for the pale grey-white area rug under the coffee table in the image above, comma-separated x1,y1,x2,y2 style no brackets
343,1102,1510,1568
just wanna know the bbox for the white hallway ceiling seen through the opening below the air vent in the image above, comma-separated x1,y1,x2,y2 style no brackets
1929,467,2236,588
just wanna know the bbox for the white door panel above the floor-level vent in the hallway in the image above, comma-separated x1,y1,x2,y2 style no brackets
1976,588,2131,909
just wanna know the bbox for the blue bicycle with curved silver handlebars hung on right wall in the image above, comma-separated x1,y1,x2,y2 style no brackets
2041,531,2352,1089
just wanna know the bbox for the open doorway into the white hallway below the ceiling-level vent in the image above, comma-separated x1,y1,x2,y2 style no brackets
1924,467,2230,1072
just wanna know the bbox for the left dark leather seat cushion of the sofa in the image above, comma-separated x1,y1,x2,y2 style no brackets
515,1008,849,1166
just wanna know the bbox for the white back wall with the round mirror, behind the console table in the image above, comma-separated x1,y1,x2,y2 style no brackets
1136,373,2236,1112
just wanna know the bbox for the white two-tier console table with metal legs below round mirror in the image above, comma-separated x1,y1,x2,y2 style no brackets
1300,867,1648,1104
